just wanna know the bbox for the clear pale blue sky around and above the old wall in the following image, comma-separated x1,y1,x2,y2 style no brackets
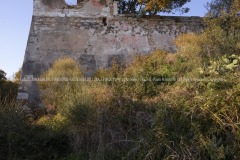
0,0,210,78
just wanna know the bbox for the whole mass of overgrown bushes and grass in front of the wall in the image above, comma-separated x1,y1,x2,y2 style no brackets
0,2,240,160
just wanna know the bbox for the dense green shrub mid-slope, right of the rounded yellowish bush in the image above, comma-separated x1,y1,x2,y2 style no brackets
96,51,180,99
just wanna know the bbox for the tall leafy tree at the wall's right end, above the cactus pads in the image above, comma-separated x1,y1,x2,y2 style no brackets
205,0,240,55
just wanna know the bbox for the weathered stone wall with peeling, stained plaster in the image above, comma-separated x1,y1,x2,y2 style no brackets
19,0,203,104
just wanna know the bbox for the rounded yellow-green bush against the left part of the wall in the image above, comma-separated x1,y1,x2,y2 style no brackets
39,57,82,115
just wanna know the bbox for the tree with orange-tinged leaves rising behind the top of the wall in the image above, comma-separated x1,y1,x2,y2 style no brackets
119,0,191,15
